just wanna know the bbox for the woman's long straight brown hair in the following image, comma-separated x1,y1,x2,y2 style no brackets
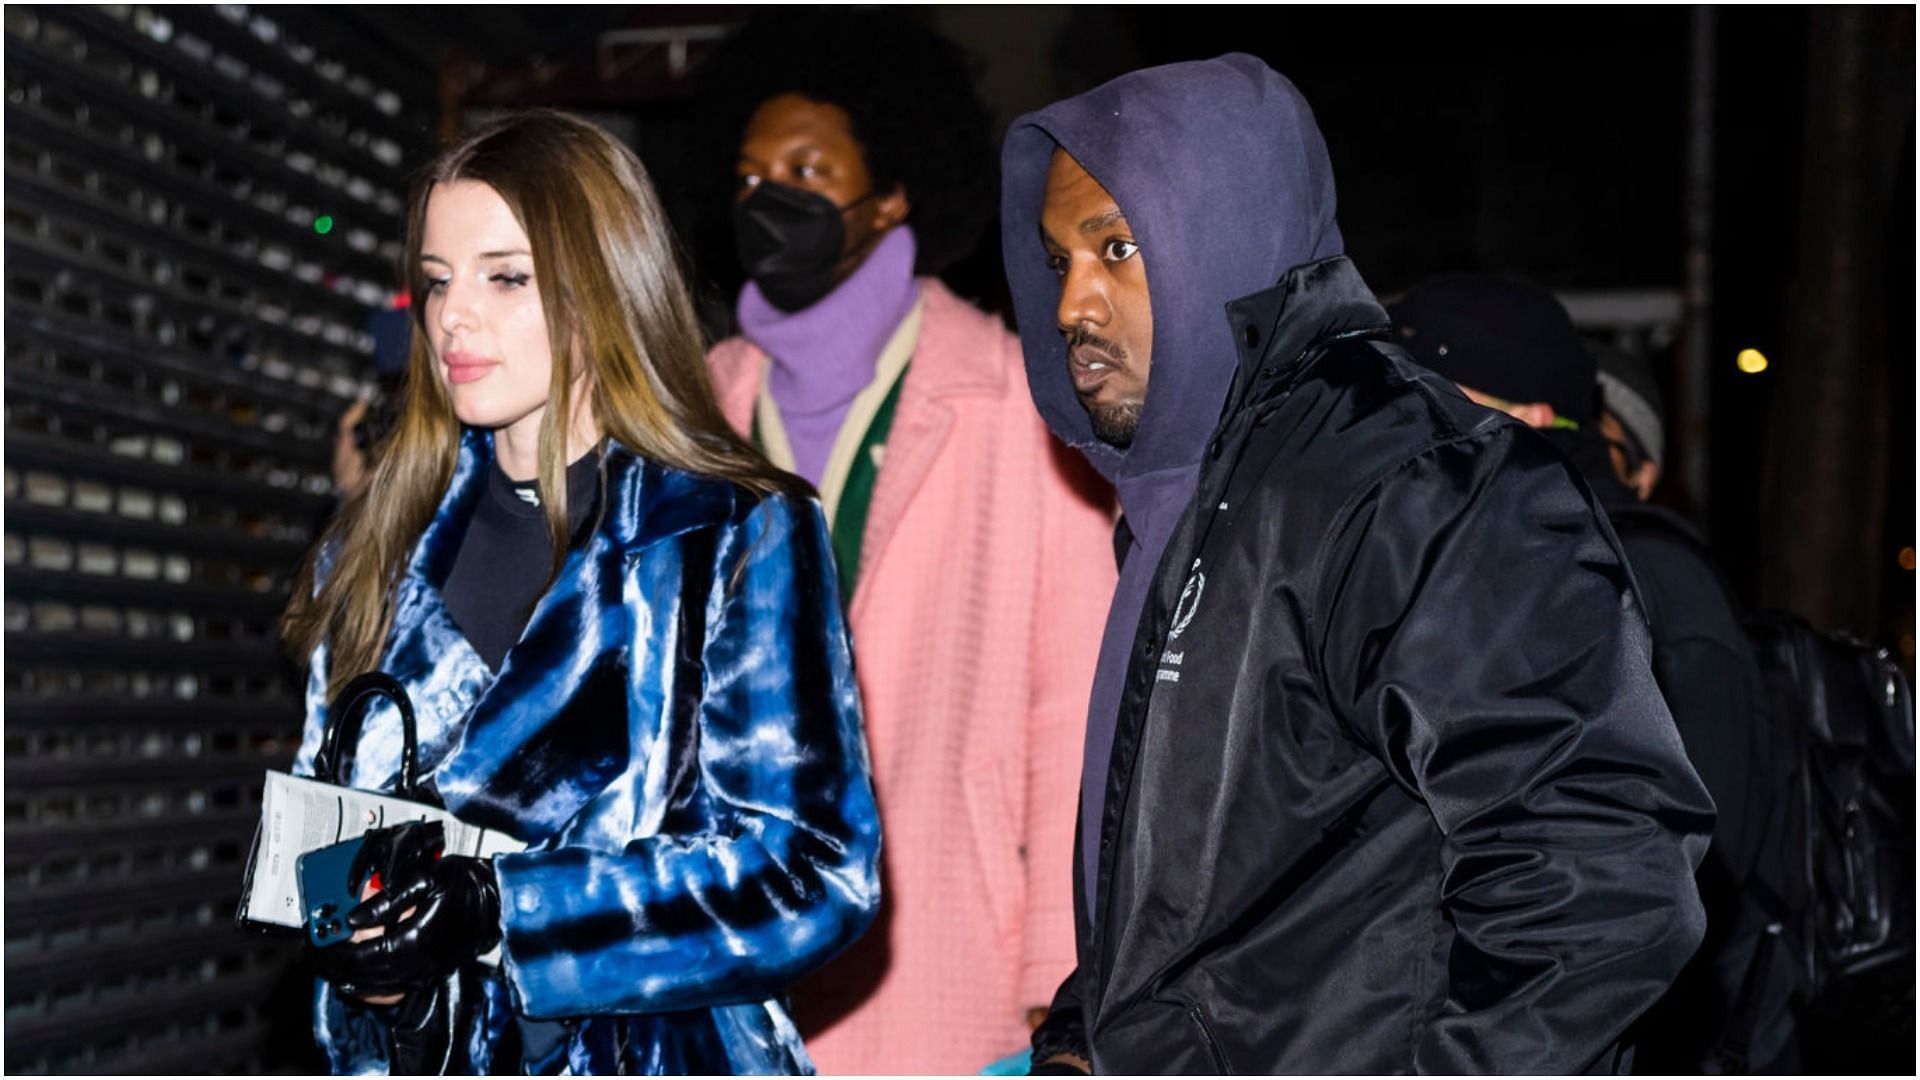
280,110,806,698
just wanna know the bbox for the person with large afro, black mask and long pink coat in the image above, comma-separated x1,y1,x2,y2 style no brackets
708,8,1114,1072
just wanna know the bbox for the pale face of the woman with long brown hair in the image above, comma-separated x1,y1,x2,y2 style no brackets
420,181,553,448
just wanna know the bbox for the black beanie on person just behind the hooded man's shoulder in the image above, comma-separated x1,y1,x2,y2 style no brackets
1388,273,1596,429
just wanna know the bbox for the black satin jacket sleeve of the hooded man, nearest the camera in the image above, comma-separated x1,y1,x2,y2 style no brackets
1315,425,1713,1074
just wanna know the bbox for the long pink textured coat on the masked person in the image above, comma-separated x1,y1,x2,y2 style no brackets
707,279,1116,1074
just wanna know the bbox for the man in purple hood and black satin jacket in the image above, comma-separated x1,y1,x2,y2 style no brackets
1002,56,1713,1072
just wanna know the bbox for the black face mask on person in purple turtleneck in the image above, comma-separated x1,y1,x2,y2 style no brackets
733,181,874,311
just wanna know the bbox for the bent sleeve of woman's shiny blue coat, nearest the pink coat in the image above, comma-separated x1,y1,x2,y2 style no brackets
493,496,879,1019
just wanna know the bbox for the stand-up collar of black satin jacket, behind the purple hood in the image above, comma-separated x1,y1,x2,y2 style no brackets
1227,256,1392,411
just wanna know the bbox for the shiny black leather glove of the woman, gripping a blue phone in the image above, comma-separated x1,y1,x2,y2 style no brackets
315,824,501,997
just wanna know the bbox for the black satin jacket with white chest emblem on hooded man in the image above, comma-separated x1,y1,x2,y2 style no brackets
1035,258,1715,1072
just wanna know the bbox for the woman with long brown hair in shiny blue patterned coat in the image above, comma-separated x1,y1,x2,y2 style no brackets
284,111,879,1072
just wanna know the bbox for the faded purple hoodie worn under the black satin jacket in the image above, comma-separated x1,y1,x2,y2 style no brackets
1000,54,1342,917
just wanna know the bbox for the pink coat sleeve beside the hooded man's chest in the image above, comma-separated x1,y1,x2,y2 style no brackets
1018,432,1116,1011
